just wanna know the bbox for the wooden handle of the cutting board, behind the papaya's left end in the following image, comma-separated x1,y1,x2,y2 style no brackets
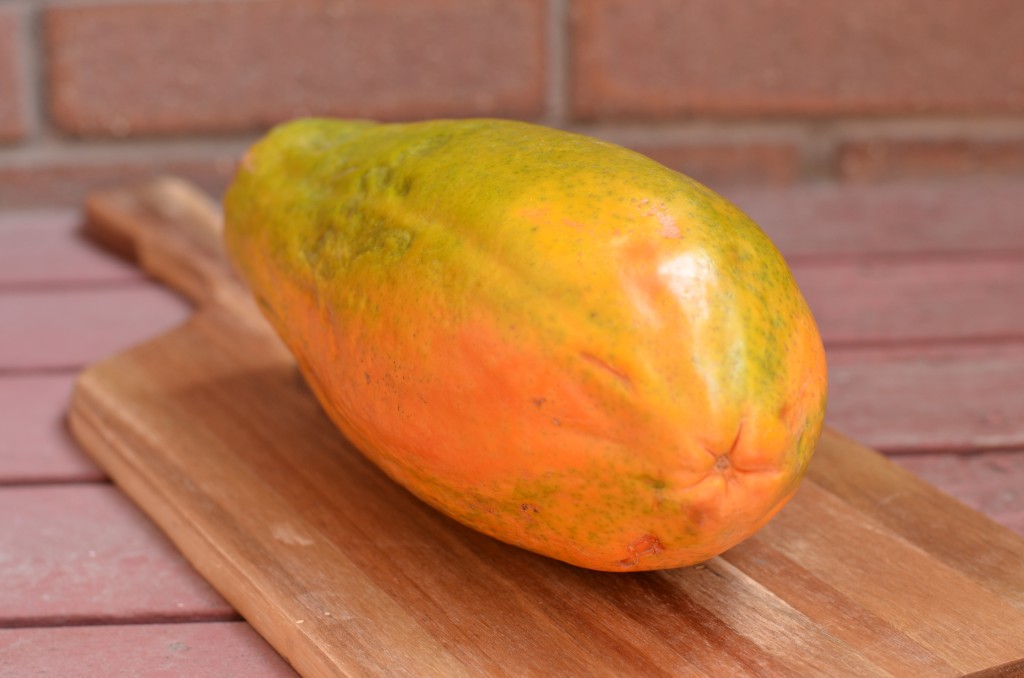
84,177,242,306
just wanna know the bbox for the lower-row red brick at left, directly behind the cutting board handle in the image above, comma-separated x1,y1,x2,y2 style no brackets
0,154,236,208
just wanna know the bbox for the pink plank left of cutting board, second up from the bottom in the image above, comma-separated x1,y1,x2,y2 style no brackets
0,484,234,627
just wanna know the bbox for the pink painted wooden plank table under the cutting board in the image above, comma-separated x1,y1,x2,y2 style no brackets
0,181,1024,678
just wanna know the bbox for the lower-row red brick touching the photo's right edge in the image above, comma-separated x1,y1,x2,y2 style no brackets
839,139,1024,181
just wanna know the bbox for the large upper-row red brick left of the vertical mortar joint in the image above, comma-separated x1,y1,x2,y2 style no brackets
45,0,546,135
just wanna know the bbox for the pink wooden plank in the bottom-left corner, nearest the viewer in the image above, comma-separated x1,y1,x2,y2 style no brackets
0,622,296,678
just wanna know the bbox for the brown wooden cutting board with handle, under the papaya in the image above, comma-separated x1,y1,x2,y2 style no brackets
70,180,1024,676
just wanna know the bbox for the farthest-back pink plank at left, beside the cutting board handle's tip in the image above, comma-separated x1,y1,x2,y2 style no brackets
0,210,142,289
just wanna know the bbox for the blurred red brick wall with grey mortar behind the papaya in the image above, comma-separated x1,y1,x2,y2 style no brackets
0,0,1024,207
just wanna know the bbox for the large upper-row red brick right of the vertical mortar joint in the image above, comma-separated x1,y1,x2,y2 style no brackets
571,0,1024,119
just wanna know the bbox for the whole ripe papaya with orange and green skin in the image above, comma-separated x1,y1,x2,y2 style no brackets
225,119,826,571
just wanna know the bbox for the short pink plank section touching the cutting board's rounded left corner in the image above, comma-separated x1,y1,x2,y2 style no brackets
0,375,104,484
